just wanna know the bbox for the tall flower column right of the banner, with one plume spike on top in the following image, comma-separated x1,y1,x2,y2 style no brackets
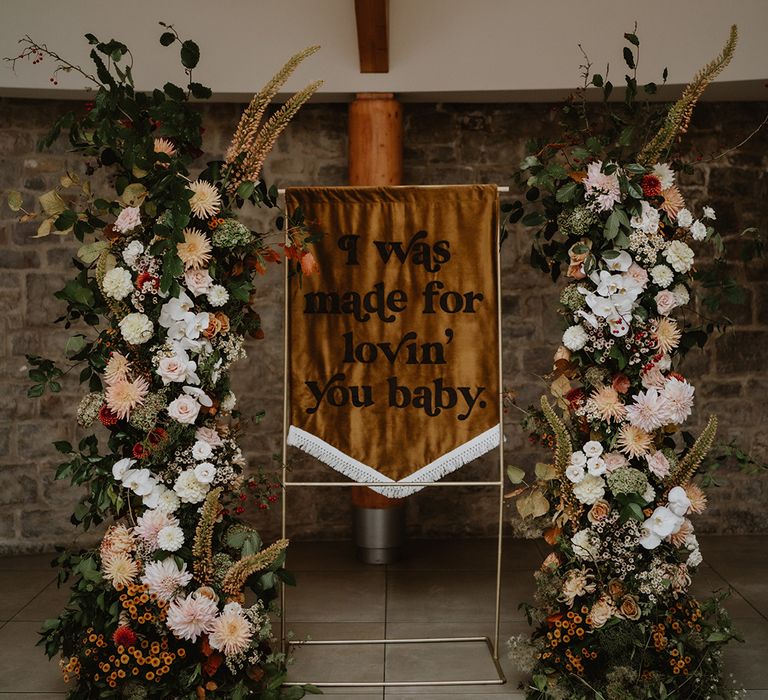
507,27,752,700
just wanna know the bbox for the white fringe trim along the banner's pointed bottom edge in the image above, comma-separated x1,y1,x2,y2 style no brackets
287,425,501,498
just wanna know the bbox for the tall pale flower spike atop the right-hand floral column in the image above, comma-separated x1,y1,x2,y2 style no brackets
637,24,738,165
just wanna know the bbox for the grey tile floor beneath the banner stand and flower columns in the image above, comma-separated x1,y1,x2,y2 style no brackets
0,536,768,700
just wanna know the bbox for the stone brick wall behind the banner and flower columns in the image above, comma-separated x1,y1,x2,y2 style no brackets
0,99,768,551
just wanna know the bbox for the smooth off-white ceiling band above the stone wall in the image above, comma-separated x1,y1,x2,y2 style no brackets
0,0,768,101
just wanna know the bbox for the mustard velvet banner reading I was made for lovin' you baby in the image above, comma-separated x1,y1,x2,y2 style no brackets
286,185,501,498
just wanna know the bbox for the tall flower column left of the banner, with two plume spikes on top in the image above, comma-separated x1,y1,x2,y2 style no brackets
9,25,319,698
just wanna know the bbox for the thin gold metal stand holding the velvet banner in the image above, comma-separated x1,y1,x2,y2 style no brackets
279,185,509,688
